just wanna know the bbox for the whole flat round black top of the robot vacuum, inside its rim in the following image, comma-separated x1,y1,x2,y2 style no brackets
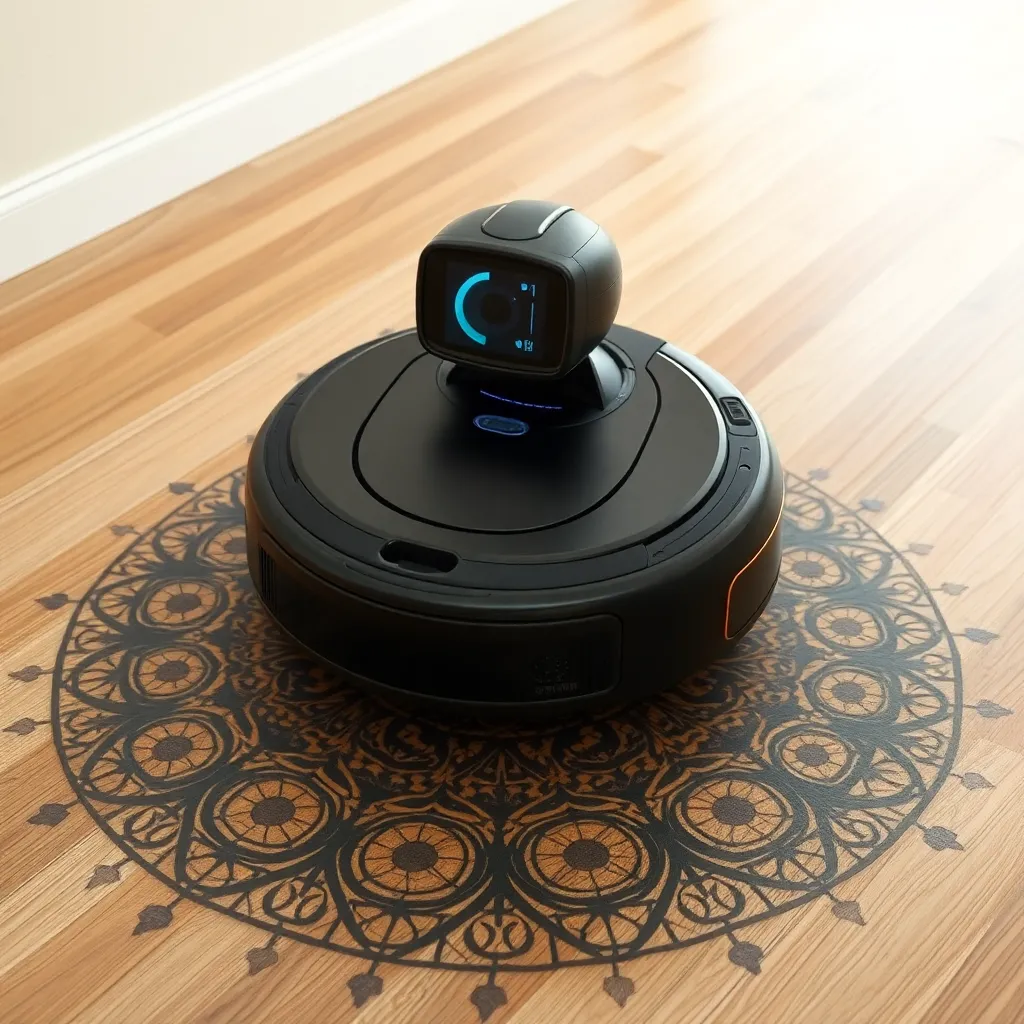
286,328,728,564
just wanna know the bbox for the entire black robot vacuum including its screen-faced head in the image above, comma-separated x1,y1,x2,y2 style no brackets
246,201,783,716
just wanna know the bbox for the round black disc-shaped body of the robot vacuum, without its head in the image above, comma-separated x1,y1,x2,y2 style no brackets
246,327,783,717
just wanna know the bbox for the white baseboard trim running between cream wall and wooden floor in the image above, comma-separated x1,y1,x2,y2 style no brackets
0,0,569,282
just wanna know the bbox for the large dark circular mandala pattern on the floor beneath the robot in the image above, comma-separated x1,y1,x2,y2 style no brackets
54,471,962,966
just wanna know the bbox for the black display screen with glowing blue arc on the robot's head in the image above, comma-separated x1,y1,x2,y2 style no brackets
421,251,567,370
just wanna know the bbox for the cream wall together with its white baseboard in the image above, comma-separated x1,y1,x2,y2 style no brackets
0,0,570,282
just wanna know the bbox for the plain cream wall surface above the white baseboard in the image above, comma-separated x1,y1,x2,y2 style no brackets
0,0,407,185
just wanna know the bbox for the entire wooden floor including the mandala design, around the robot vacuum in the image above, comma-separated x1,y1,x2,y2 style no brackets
0,0,1024,1024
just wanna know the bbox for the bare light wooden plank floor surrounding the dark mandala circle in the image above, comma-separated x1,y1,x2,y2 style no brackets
0,0,1024,1024
